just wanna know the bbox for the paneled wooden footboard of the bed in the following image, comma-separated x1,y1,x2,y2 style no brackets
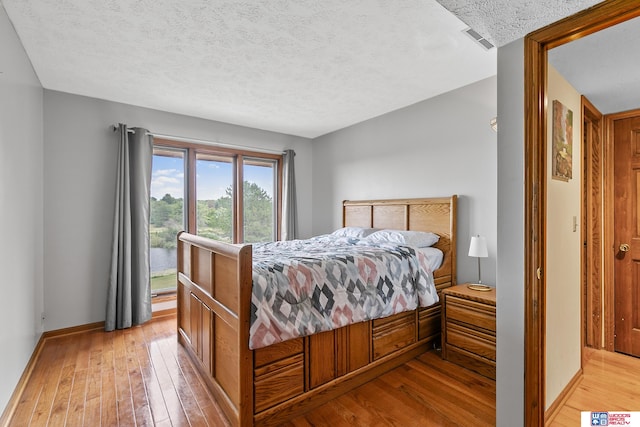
178,233,253,426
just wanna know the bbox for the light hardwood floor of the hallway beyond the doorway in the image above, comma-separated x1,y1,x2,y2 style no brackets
547,349,640,427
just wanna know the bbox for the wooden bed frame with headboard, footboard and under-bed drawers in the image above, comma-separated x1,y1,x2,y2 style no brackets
178,195,457,426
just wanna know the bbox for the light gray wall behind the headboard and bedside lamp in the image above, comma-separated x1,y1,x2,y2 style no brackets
312,77,497,284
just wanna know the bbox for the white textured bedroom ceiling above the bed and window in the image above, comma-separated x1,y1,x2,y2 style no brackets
0,0,608,137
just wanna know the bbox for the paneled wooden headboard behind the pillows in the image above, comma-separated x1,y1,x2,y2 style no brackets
342,195,458,287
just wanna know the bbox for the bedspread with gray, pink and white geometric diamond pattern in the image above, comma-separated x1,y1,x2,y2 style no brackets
249,235,438,349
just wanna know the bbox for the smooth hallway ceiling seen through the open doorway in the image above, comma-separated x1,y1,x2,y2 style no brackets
549,18,640,114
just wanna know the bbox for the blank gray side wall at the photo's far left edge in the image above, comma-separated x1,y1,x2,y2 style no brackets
0,7,43,411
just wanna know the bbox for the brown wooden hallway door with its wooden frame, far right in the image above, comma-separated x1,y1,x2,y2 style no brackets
582,96,640,357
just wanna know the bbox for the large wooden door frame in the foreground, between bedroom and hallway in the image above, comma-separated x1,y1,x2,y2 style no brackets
524,0,640,427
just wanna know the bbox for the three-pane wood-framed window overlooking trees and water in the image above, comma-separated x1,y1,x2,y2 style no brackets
149,139,282,295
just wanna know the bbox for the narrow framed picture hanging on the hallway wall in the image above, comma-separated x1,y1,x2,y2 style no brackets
551,99,573,181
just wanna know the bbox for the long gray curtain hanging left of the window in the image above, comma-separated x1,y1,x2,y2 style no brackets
105,124,153,331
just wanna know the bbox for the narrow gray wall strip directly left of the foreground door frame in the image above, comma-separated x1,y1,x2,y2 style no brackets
496,39,524,427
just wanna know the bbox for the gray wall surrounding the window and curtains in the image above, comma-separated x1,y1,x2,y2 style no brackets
44,90,312,330
